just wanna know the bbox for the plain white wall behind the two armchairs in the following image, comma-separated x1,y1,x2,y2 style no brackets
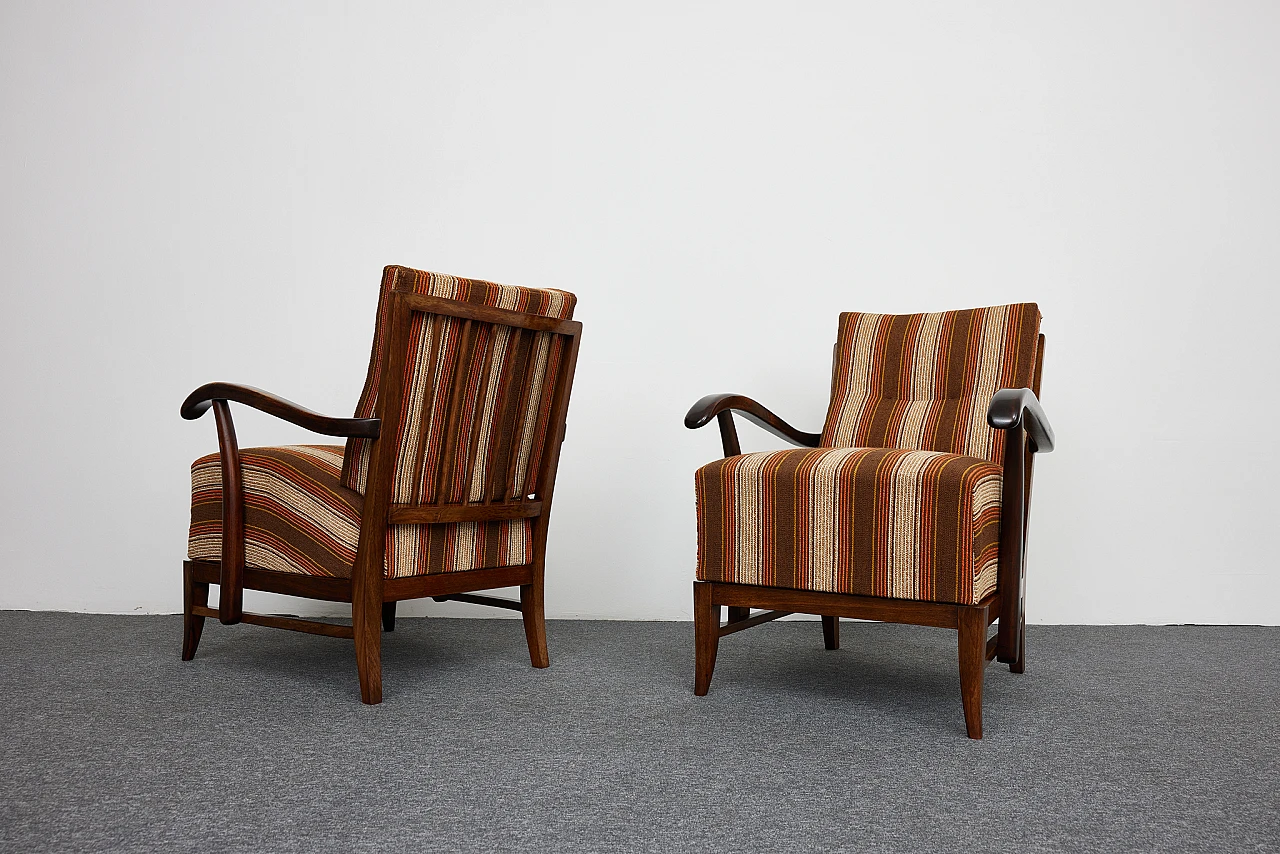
0,0,1280,624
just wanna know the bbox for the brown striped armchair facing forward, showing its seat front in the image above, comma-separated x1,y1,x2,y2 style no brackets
685,303,1053,739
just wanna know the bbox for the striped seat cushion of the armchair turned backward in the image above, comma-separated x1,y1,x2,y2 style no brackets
187,446,532,577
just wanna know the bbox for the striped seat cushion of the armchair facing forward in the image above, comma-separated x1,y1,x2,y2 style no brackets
695,448,1001,604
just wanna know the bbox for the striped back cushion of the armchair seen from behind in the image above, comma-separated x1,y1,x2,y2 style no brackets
342,266,576,504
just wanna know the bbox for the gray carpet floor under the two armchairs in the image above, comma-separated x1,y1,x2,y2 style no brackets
0,612,1280,851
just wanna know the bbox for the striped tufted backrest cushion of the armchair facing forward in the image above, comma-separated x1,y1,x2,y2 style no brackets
822,302,1041,462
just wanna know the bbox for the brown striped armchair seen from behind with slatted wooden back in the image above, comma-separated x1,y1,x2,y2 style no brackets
182,266,582,703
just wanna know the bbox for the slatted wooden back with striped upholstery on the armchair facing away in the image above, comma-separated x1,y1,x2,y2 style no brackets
342,266,581,577
